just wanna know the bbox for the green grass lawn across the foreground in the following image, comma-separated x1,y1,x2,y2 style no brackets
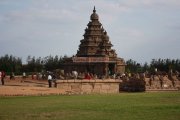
0,92,180,120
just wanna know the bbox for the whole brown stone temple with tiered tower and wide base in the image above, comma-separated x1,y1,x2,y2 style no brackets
64,7,125,76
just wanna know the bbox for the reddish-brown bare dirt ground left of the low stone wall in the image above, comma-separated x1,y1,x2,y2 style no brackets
0,77,66,96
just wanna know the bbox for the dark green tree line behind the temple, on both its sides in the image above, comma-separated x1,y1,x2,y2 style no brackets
0,55,180,74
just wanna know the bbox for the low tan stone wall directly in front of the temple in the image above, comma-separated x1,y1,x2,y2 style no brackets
57,80,122,94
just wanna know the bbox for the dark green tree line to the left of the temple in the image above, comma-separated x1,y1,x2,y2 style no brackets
0,55,67,74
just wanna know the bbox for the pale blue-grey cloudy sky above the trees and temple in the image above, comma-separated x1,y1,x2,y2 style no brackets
0,0,180,63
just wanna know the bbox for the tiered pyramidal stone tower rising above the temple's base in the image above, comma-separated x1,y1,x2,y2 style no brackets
77,7,117,58
